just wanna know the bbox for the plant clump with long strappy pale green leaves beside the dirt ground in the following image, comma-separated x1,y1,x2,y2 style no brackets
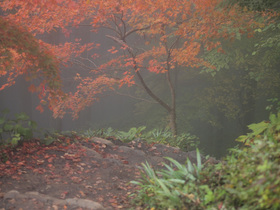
131,150,205,209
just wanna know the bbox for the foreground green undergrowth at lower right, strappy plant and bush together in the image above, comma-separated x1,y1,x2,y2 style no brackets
132,113,280,210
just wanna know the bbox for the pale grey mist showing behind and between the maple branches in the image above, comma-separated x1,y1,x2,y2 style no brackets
0,16,279,158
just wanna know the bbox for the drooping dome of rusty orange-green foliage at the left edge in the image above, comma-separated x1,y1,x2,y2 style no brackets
0,17,63,112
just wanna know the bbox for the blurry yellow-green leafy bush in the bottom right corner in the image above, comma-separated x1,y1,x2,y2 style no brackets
219,113,280,209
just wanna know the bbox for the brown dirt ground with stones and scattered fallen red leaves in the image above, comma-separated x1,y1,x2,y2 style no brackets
0,136,208,210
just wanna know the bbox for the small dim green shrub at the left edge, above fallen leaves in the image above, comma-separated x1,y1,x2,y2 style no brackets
0,109,37,146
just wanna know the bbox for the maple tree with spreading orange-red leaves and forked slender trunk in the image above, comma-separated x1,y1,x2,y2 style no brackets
0,0,272,135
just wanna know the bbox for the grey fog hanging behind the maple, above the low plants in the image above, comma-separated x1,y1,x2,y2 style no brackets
0,23,278,158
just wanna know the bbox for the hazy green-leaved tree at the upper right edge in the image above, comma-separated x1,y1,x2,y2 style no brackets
201,0,280,128
